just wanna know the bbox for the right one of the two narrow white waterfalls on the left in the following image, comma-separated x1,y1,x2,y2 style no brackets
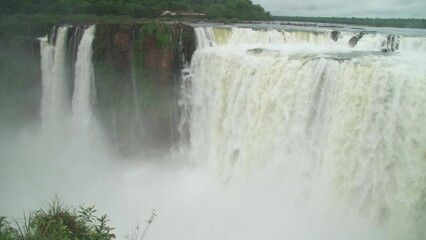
72,26,98,131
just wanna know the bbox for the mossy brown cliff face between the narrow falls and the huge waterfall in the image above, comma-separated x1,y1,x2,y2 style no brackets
94,22,195,153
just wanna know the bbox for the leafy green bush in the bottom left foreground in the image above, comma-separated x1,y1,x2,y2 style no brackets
0,199,115,240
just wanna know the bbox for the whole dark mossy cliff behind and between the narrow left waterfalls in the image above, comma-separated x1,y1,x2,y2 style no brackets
0,21,195,153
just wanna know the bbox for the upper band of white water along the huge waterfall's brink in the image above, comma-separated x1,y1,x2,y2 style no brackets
195,27,426,53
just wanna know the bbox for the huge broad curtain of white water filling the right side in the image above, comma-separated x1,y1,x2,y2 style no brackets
181,28,426,239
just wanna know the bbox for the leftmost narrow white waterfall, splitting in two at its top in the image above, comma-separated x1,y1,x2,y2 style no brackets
41,27,69,129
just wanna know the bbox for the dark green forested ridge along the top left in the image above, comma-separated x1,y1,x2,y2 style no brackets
0,0,270,20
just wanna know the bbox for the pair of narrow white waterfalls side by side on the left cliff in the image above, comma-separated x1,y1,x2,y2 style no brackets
40,26,98,134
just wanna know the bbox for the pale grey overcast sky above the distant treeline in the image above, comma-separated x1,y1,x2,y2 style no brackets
252,0,426,18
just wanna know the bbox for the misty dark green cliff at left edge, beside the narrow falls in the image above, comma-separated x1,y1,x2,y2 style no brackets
0,26,45,127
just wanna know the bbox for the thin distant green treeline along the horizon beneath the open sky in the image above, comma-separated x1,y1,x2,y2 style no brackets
272,16,426,28
